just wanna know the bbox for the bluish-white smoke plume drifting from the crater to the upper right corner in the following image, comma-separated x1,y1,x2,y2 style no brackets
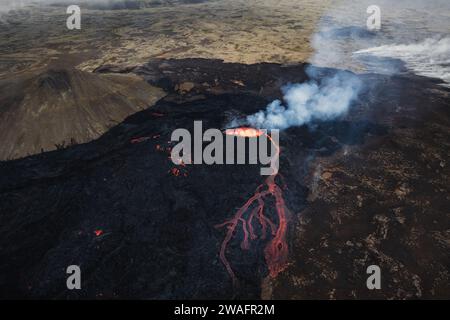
246,0,450,129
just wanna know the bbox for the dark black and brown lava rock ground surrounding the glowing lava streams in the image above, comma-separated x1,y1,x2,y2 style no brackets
0,59,450,299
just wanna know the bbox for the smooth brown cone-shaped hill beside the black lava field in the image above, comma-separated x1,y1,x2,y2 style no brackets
0,67,164,160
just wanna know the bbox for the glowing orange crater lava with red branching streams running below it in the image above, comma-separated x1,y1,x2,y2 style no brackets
217,128,288,286
